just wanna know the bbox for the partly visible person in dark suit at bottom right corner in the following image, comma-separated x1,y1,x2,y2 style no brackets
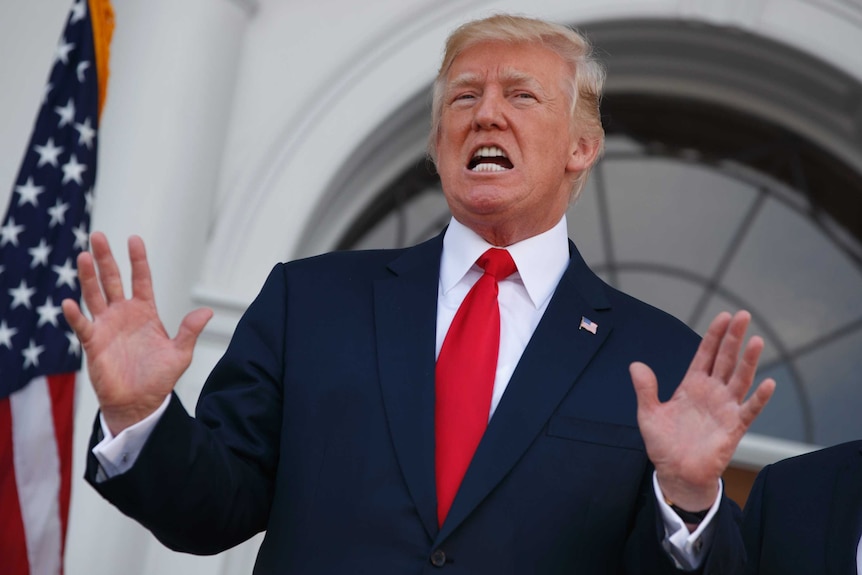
743,441,862,575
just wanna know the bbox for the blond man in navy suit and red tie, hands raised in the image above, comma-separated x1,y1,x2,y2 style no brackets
64,16,774,574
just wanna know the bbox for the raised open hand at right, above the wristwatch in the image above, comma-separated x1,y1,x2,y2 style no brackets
629,311,775,511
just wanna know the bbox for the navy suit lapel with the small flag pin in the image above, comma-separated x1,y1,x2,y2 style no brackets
437,244,613,542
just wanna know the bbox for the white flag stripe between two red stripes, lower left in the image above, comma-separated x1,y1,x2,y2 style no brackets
9,377,62,575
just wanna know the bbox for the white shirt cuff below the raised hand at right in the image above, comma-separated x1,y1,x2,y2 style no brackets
652,472,724,571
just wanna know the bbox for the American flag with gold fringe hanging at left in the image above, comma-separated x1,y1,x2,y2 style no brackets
0,0,113,575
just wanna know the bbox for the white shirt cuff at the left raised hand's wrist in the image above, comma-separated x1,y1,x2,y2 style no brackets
93,395,171,483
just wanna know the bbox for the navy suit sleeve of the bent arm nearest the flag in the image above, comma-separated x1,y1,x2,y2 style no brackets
85,266,287,554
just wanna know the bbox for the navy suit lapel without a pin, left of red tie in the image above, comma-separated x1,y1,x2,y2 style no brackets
374,234,443,539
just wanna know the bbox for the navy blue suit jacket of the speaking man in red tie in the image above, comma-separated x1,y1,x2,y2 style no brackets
87,236,744,575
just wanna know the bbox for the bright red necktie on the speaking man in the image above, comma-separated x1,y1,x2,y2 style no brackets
434,248,516,525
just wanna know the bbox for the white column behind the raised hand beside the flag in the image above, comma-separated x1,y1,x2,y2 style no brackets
66,0,250,575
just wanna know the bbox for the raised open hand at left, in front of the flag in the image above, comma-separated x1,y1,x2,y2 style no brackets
63,233,212,435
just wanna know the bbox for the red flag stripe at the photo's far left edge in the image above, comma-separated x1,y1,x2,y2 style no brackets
0,398,30,573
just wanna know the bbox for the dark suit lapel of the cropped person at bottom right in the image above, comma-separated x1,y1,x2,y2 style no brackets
826,442,862,575
